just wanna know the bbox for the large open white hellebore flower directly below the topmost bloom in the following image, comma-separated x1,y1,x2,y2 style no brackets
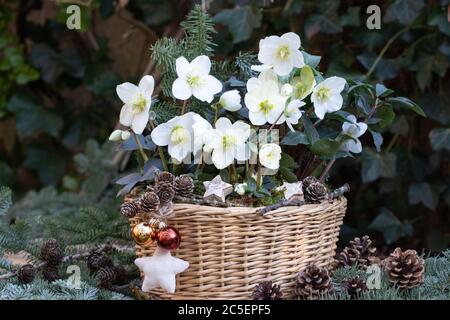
244,72,288,126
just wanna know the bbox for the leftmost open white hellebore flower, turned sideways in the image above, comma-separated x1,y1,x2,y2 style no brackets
116,76,155,134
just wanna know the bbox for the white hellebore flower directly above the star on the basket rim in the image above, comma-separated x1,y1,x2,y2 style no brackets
204,118,250,170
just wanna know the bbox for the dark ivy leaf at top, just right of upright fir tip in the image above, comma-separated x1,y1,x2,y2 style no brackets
213,6,262,43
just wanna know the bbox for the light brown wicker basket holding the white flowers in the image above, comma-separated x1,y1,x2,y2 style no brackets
130,197,347,300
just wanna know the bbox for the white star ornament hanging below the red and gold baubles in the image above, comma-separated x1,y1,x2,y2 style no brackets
134,247,189,293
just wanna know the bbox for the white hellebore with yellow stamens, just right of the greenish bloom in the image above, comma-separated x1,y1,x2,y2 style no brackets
311,77,345,119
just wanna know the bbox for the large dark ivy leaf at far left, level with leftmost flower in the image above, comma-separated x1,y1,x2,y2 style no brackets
7,93,63,137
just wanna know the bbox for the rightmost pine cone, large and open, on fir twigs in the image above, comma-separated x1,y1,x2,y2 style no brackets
383,248,424,289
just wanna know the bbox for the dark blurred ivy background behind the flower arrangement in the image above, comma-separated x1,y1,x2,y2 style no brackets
0,0,450,252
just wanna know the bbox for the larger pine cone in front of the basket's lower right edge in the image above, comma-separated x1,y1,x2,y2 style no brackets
294,265,332,299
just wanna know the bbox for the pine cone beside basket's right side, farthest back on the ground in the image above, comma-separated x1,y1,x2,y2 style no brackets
337,235,379,267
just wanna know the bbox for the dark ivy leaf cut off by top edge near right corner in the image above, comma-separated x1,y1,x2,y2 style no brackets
384,0,424,25
